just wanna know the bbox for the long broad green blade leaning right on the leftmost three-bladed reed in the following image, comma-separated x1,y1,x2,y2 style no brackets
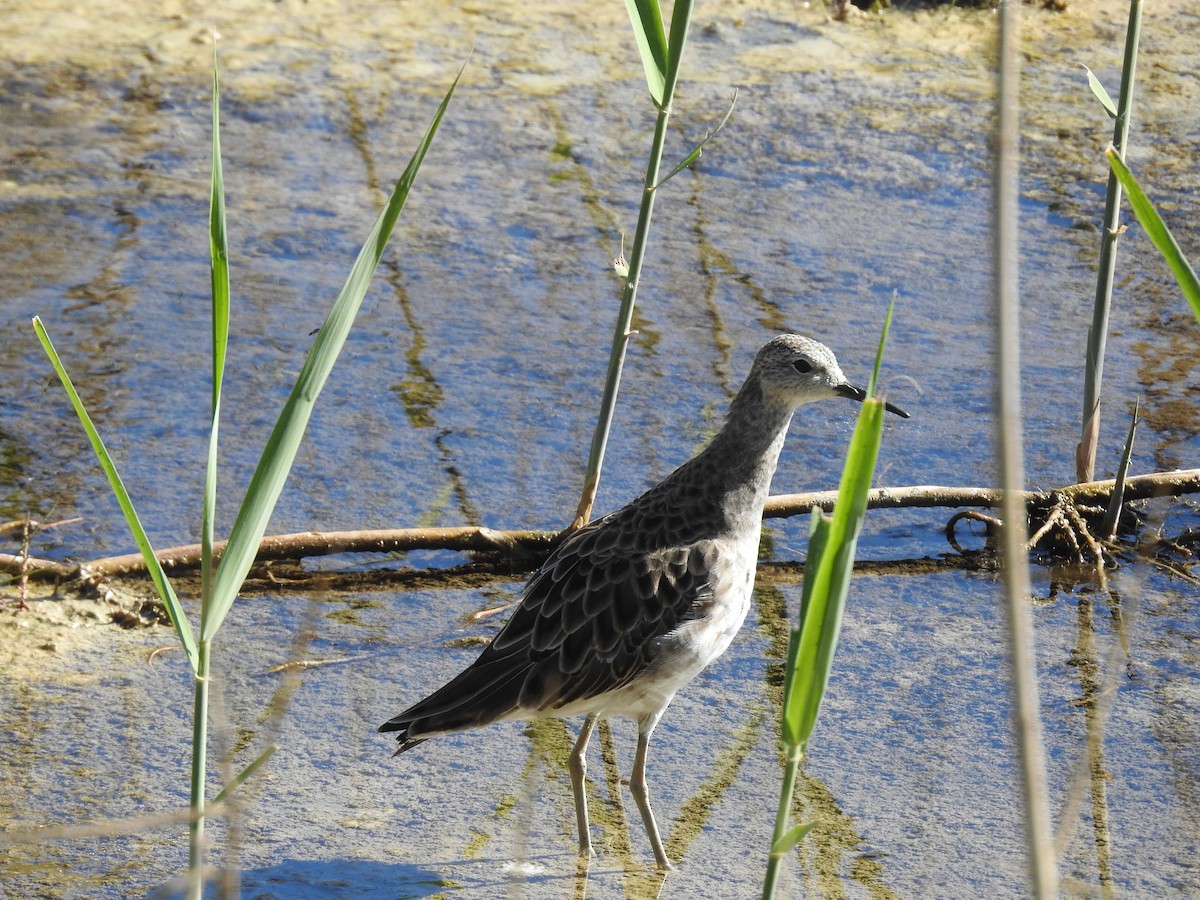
200,71,462,640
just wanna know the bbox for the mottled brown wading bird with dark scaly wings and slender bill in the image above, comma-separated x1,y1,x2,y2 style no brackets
379,335,907,869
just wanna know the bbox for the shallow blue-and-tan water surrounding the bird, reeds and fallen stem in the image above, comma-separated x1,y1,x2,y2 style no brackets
0,2,1200,896
